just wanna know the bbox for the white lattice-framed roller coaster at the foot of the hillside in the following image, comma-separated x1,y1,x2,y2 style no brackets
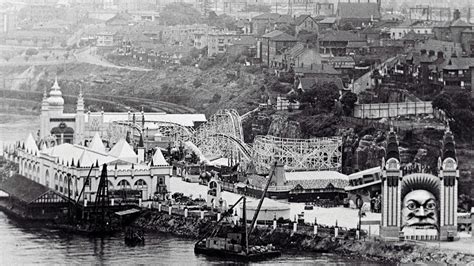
108,109,342,174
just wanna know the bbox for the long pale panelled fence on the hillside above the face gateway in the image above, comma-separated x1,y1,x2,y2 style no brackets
354,102,433,119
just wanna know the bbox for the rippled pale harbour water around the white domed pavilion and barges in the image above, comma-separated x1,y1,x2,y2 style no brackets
0,114,366,265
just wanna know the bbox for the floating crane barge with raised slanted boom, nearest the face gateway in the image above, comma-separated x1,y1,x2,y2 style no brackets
194,161,281,261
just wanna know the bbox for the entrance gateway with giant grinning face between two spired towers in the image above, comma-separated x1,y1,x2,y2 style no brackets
380,130,459,240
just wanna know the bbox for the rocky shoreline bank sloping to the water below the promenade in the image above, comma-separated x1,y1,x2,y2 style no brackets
134,211,474,264
